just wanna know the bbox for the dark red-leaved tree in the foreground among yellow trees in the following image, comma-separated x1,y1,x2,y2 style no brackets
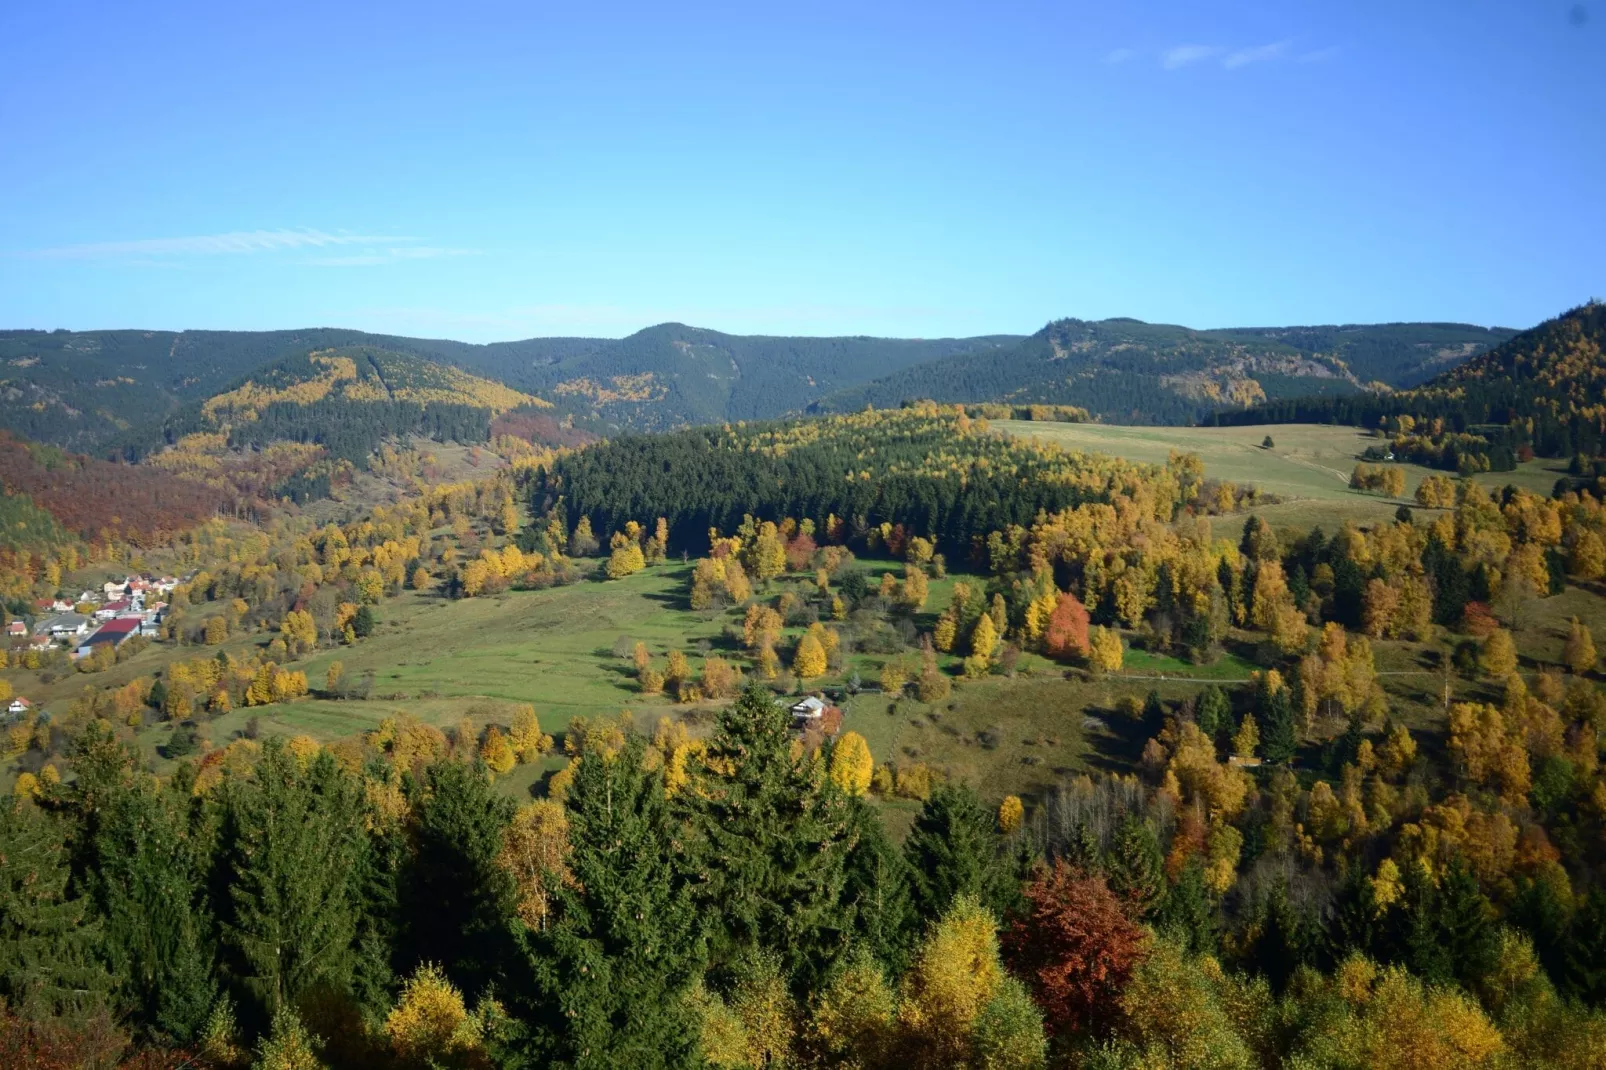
1004,860,1147,1036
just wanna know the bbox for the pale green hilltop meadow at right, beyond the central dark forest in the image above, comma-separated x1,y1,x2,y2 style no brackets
994,419,1564,530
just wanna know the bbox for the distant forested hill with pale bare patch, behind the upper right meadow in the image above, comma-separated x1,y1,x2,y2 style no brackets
814,318,1514,424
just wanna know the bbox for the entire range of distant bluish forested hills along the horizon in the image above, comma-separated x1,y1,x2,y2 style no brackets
0,320,1513,451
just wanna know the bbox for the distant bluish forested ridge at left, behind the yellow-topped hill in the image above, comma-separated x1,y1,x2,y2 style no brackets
0,323,1020,450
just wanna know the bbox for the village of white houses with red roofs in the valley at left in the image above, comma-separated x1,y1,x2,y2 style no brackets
5,575,180,721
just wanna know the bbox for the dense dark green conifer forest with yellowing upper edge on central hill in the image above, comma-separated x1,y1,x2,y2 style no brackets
532,405,1161,551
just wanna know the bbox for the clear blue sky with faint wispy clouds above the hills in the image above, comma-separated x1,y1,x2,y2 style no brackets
0,0,1606,341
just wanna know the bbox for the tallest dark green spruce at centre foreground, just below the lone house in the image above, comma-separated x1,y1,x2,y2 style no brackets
686,684,851,991
